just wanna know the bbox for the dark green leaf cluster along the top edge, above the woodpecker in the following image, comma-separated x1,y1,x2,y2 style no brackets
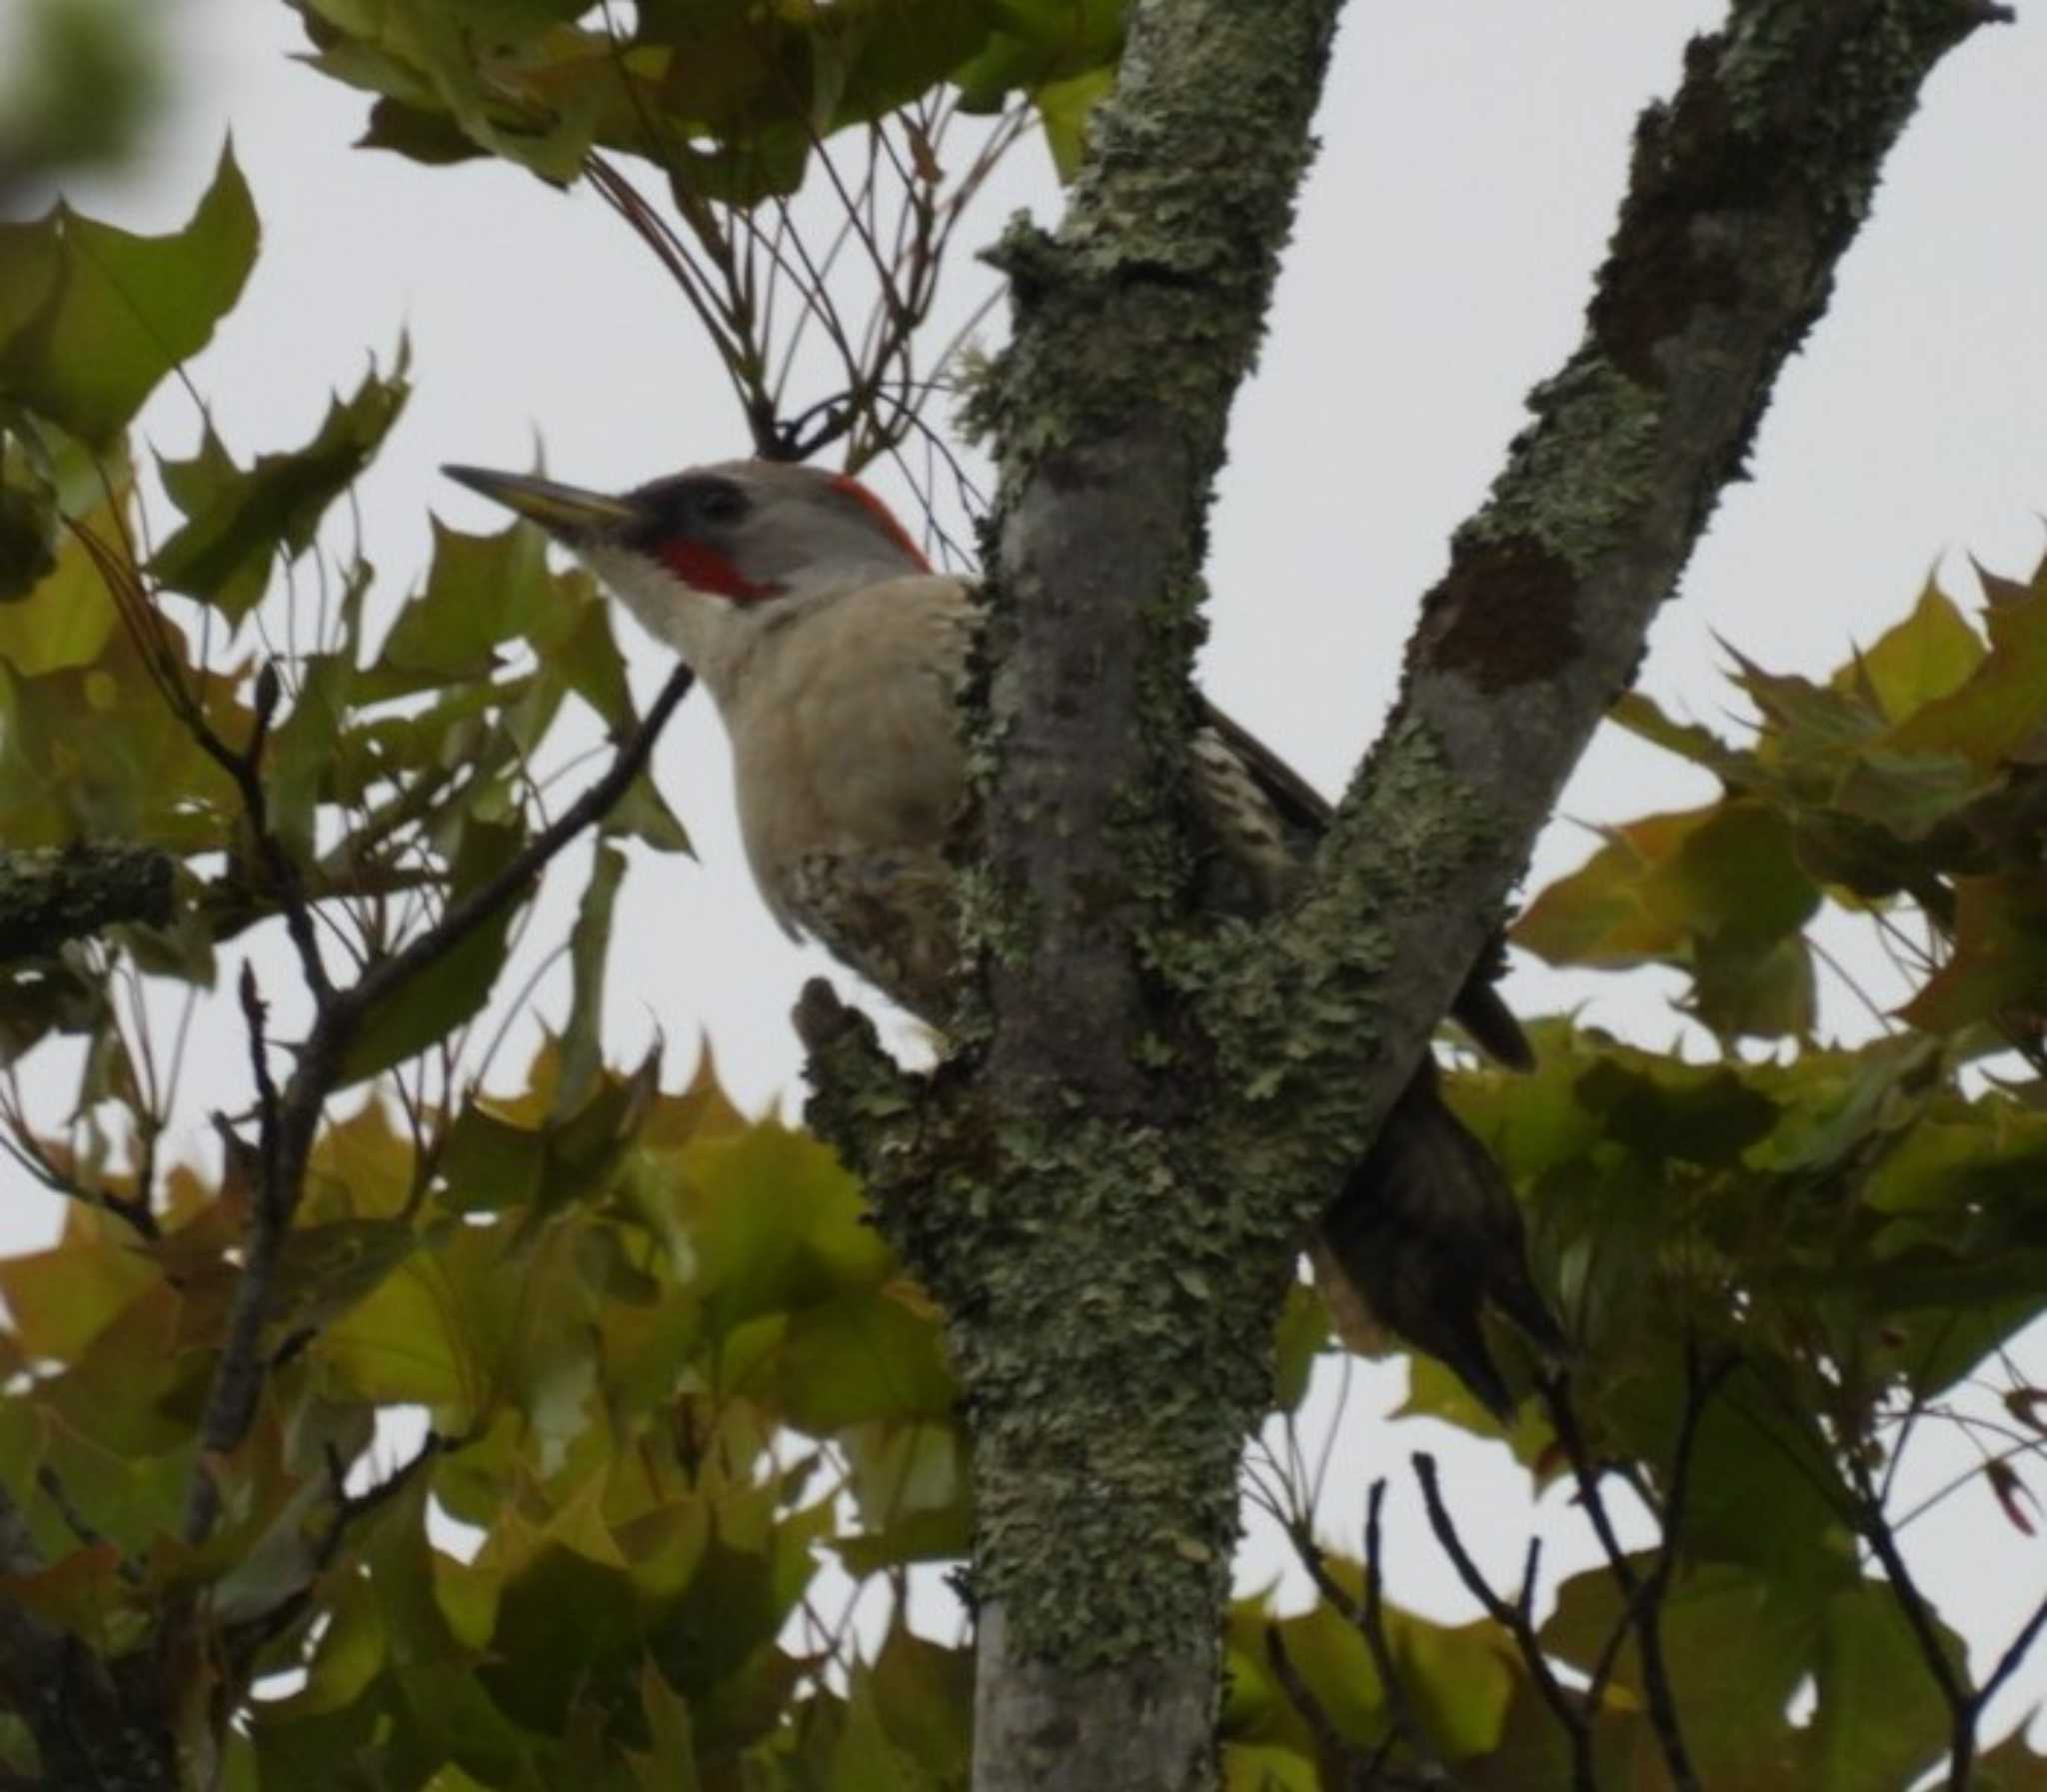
289,0,1123,205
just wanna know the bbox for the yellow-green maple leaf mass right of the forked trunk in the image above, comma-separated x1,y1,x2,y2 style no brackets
1195,577,2047,1792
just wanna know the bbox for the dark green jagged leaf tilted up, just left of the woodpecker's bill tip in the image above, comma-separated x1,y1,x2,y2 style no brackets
150,342,412,621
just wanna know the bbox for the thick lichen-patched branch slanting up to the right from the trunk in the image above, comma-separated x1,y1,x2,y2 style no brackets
1189,0,2002,1285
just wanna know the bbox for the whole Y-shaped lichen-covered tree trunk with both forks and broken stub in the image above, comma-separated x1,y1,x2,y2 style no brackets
799,0,1994,1792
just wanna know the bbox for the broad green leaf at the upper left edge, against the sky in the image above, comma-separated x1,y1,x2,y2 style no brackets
0,148,256,447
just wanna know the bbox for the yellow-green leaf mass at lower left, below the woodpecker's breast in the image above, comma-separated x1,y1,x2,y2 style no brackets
0,1042,971,1792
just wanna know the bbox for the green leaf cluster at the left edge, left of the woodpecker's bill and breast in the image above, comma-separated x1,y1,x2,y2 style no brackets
0,154,686,1075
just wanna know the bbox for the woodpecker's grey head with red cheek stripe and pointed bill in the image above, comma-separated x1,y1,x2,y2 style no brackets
442,461,932,691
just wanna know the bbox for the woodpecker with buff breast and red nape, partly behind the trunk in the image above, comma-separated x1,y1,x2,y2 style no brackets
444,461,1566,1423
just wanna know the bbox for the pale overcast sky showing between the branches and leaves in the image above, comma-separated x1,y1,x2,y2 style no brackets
16,0,2047,1769
